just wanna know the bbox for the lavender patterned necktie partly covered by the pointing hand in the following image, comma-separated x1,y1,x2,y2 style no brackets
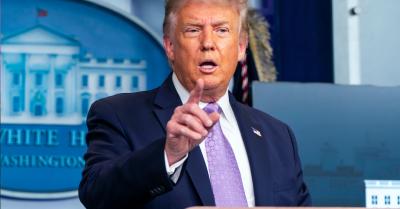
204,103,247,207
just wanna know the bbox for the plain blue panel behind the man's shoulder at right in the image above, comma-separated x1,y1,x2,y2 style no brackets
253,82,400,207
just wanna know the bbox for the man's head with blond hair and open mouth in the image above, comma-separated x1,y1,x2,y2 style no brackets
164,2,247,99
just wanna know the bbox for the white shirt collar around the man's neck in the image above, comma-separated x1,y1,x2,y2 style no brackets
172,73,235,121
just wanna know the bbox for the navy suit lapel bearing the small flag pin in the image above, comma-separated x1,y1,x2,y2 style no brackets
229,94,273,206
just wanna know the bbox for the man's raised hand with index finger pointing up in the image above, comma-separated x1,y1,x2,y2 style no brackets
165,79,219,165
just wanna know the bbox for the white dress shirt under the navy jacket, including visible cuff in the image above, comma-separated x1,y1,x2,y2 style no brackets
164,73,255,207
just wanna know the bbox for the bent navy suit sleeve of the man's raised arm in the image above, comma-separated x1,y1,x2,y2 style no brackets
79,100,172,209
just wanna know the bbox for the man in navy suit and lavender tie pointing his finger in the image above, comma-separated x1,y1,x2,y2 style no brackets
79,0,310,208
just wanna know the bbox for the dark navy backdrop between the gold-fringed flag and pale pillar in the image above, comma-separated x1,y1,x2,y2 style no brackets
262,0,333,83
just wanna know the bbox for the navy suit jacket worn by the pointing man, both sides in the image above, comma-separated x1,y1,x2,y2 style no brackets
79,76,311,209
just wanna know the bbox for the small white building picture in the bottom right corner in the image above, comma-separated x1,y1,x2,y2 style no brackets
364,180,400,208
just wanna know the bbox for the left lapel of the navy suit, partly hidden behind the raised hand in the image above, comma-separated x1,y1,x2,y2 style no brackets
154,75,215,205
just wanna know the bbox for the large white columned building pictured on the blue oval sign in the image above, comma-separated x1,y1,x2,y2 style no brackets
0,25,147,124
